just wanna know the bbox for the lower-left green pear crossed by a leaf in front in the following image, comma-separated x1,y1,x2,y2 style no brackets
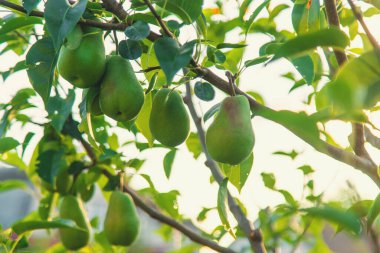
59,196,91,250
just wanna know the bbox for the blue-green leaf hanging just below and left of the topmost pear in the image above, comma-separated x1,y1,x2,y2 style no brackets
46,90,75,132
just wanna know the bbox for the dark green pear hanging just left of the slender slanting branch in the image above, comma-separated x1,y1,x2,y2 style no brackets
149,88,190,147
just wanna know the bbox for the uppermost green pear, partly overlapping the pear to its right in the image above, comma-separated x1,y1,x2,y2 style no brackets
58,25,106,88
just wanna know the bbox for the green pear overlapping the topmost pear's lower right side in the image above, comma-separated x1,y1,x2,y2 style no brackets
99,55,144,121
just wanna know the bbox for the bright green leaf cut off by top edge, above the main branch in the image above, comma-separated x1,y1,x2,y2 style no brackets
154,0,203,24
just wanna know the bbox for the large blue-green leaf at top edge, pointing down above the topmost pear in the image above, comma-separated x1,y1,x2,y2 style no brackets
44,0,87,51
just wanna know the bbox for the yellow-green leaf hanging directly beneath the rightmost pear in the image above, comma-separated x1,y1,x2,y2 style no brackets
220,153,253,192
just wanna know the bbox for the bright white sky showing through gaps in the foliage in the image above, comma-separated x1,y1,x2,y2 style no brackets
0,0,380,253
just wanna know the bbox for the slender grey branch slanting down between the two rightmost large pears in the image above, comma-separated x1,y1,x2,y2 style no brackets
185,73,266,253
